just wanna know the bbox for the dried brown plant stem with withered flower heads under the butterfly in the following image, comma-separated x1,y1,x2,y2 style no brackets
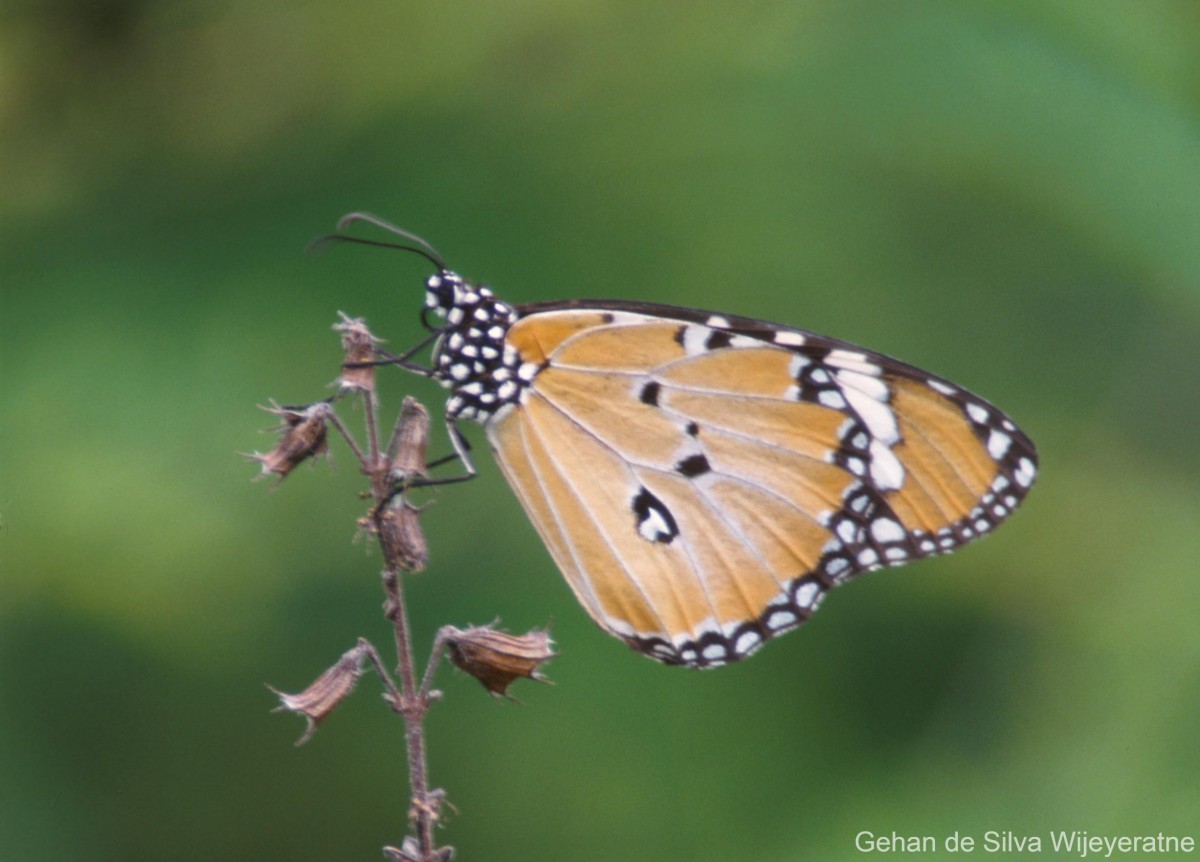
251,315,554,862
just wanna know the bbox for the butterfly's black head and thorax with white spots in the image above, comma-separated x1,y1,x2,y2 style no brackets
425,270,536,423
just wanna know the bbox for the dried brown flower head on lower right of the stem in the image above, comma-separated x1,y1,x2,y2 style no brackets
438,625,557,700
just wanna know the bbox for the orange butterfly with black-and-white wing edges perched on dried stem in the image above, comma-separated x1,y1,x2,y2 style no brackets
332,214,1038,668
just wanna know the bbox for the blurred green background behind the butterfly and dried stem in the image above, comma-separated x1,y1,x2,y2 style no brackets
0,0,1200,862
